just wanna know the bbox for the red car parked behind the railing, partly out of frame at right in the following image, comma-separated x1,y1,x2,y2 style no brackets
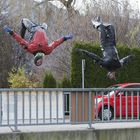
95,83,140,120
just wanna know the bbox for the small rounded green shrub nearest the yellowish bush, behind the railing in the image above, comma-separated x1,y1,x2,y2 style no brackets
43,73,56,88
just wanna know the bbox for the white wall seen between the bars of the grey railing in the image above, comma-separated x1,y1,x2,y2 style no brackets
2,92,64,120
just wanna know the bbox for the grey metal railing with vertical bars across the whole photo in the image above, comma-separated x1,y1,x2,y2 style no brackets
0,88,140,130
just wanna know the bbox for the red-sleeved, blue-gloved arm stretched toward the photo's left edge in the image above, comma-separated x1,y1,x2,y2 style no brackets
4,26,28,47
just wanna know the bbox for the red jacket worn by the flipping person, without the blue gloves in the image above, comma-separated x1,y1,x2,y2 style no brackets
12,29,65,55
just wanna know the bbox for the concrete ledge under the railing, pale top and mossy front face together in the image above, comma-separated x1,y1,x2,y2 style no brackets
0,122,140,140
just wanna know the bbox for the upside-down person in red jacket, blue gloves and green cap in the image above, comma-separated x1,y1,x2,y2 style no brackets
4,18,73,66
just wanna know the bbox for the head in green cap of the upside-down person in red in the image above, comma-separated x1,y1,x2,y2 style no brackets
34,53,45,66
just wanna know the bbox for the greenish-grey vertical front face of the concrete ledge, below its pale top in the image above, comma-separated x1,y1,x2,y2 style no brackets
0,128,140,140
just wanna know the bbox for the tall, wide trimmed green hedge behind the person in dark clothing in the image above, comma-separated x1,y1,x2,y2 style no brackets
71,42,140,88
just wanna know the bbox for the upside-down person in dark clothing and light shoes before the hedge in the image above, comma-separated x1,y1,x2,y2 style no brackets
78,19,133,80
